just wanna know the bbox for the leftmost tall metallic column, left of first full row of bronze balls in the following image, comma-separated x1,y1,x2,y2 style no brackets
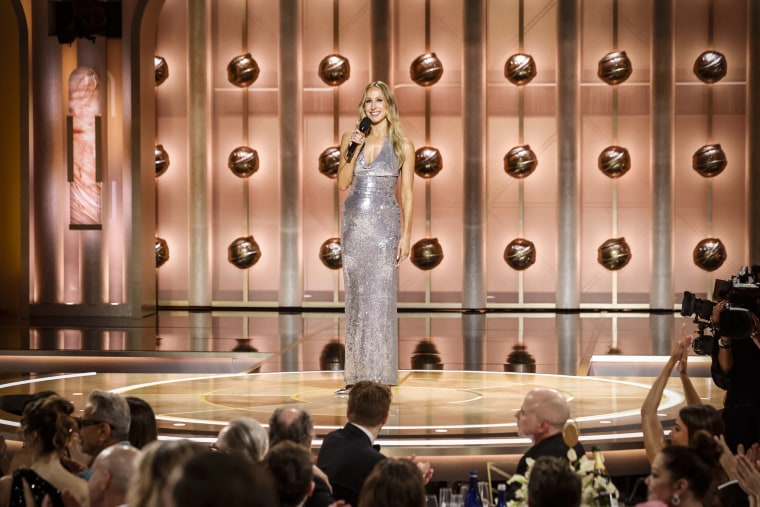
187,0,213,306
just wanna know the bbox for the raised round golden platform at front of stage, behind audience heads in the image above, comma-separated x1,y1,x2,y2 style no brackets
0,371,719,456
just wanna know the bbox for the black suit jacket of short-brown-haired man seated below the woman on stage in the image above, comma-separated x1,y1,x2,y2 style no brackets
317,423,385,506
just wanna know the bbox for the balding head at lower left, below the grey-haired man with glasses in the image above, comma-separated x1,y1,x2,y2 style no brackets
88,444,140,507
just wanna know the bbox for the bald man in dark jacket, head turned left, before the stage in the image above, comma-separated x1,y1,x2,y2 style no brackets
507,387,585,498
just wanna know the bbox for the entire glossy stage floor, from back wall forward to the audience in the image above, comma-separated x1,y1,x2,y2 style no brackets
0,314,723,480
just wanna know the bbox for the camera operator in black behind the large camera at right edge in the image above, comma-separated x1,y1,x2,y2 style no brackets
710,300,760,453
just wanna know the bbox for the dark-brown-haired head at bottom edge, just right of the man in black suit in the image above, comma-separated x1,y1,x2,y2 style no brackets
358,458,425,507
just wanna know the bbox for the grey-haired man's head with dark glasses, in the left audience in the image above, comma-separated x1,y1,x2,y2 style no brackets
78,389,131,480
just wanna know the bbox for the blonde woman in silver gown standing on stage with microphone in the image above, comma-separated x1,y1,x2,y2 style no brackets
338,81,414,394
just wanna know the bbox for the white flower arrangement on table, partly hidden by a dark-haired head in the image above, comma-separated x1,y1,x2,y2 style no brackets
507,448,620,507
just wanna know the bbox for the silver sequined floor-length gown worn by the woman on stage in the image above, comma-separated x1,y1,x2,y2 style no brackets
341,138,401,385
